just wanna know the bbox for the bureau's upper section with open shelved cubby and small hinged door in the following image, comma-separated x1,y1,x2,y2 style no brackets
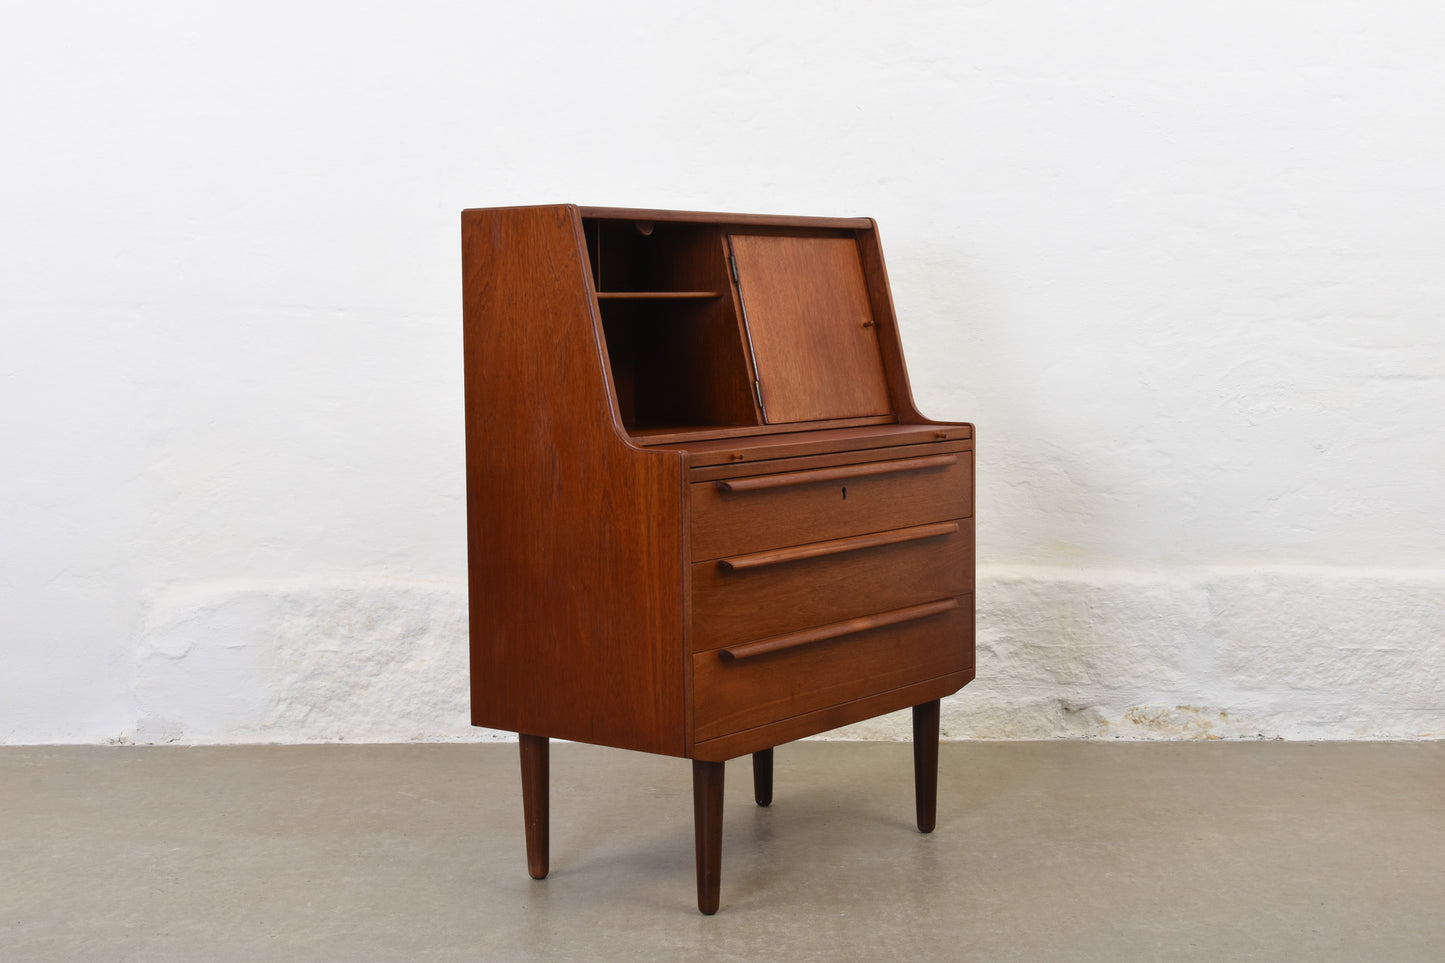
581,208,906,444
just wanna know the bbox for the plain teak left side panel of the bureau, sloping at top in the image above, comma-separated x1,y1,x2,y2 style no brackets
462,207,685,755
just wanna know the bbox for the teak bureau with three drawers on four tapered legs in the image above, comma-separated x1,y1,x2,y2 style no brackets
462,204,974,912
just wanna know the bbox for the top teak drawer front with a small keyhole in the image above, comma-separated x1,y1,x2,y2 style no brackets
689,451,974,561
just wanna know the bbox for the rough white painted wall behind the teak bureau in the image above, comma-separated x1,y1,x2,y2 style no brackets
0,0,1445,743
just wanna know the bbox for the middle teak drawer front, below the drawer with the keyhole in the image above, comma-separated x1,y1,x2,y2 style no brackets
692,518,974,652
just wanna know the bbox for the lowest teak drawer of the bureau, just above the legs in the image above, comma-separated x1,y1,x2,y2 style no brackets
692,596,974,742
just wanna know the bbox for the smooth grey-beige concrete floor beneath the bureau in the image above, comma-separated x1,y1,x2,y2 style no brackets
0,734,1445,962
